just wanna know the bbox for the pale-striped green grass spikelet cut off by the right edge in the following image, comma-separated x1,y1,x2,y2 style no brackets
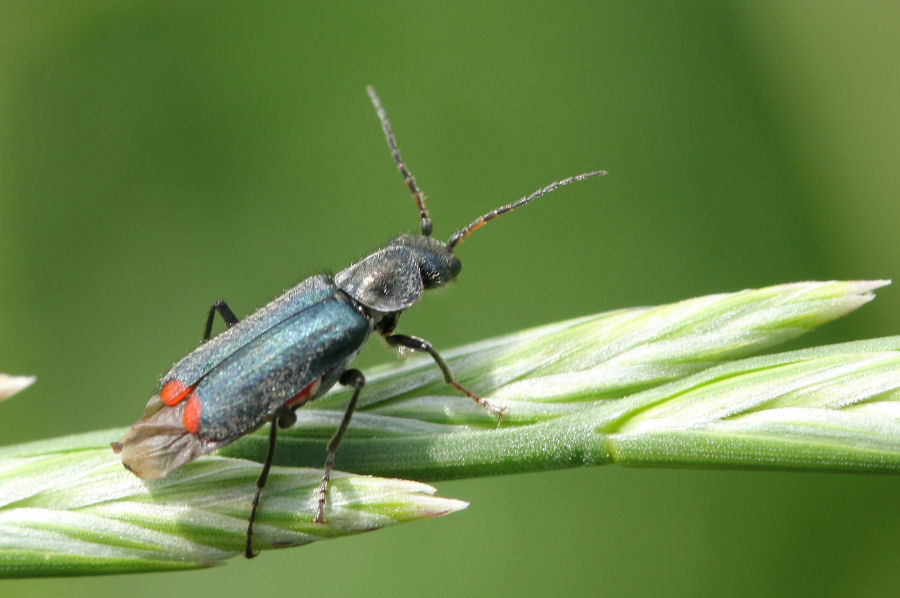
603,337,900,473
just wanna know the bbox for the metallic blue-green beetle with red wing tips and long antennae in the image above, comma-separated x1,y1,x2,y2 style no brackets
111,86,606,558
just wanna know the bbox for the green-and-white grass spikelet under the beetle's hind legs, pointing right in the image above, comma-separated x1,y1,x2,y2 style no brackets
0,442,466,578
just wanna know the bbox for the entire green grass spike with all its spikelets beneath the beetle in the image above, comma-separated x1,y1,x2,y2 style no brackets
0,281,900,577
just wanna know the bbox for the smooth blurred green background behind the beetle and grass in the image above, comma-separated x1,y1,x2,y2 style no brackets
0,1,900,598
